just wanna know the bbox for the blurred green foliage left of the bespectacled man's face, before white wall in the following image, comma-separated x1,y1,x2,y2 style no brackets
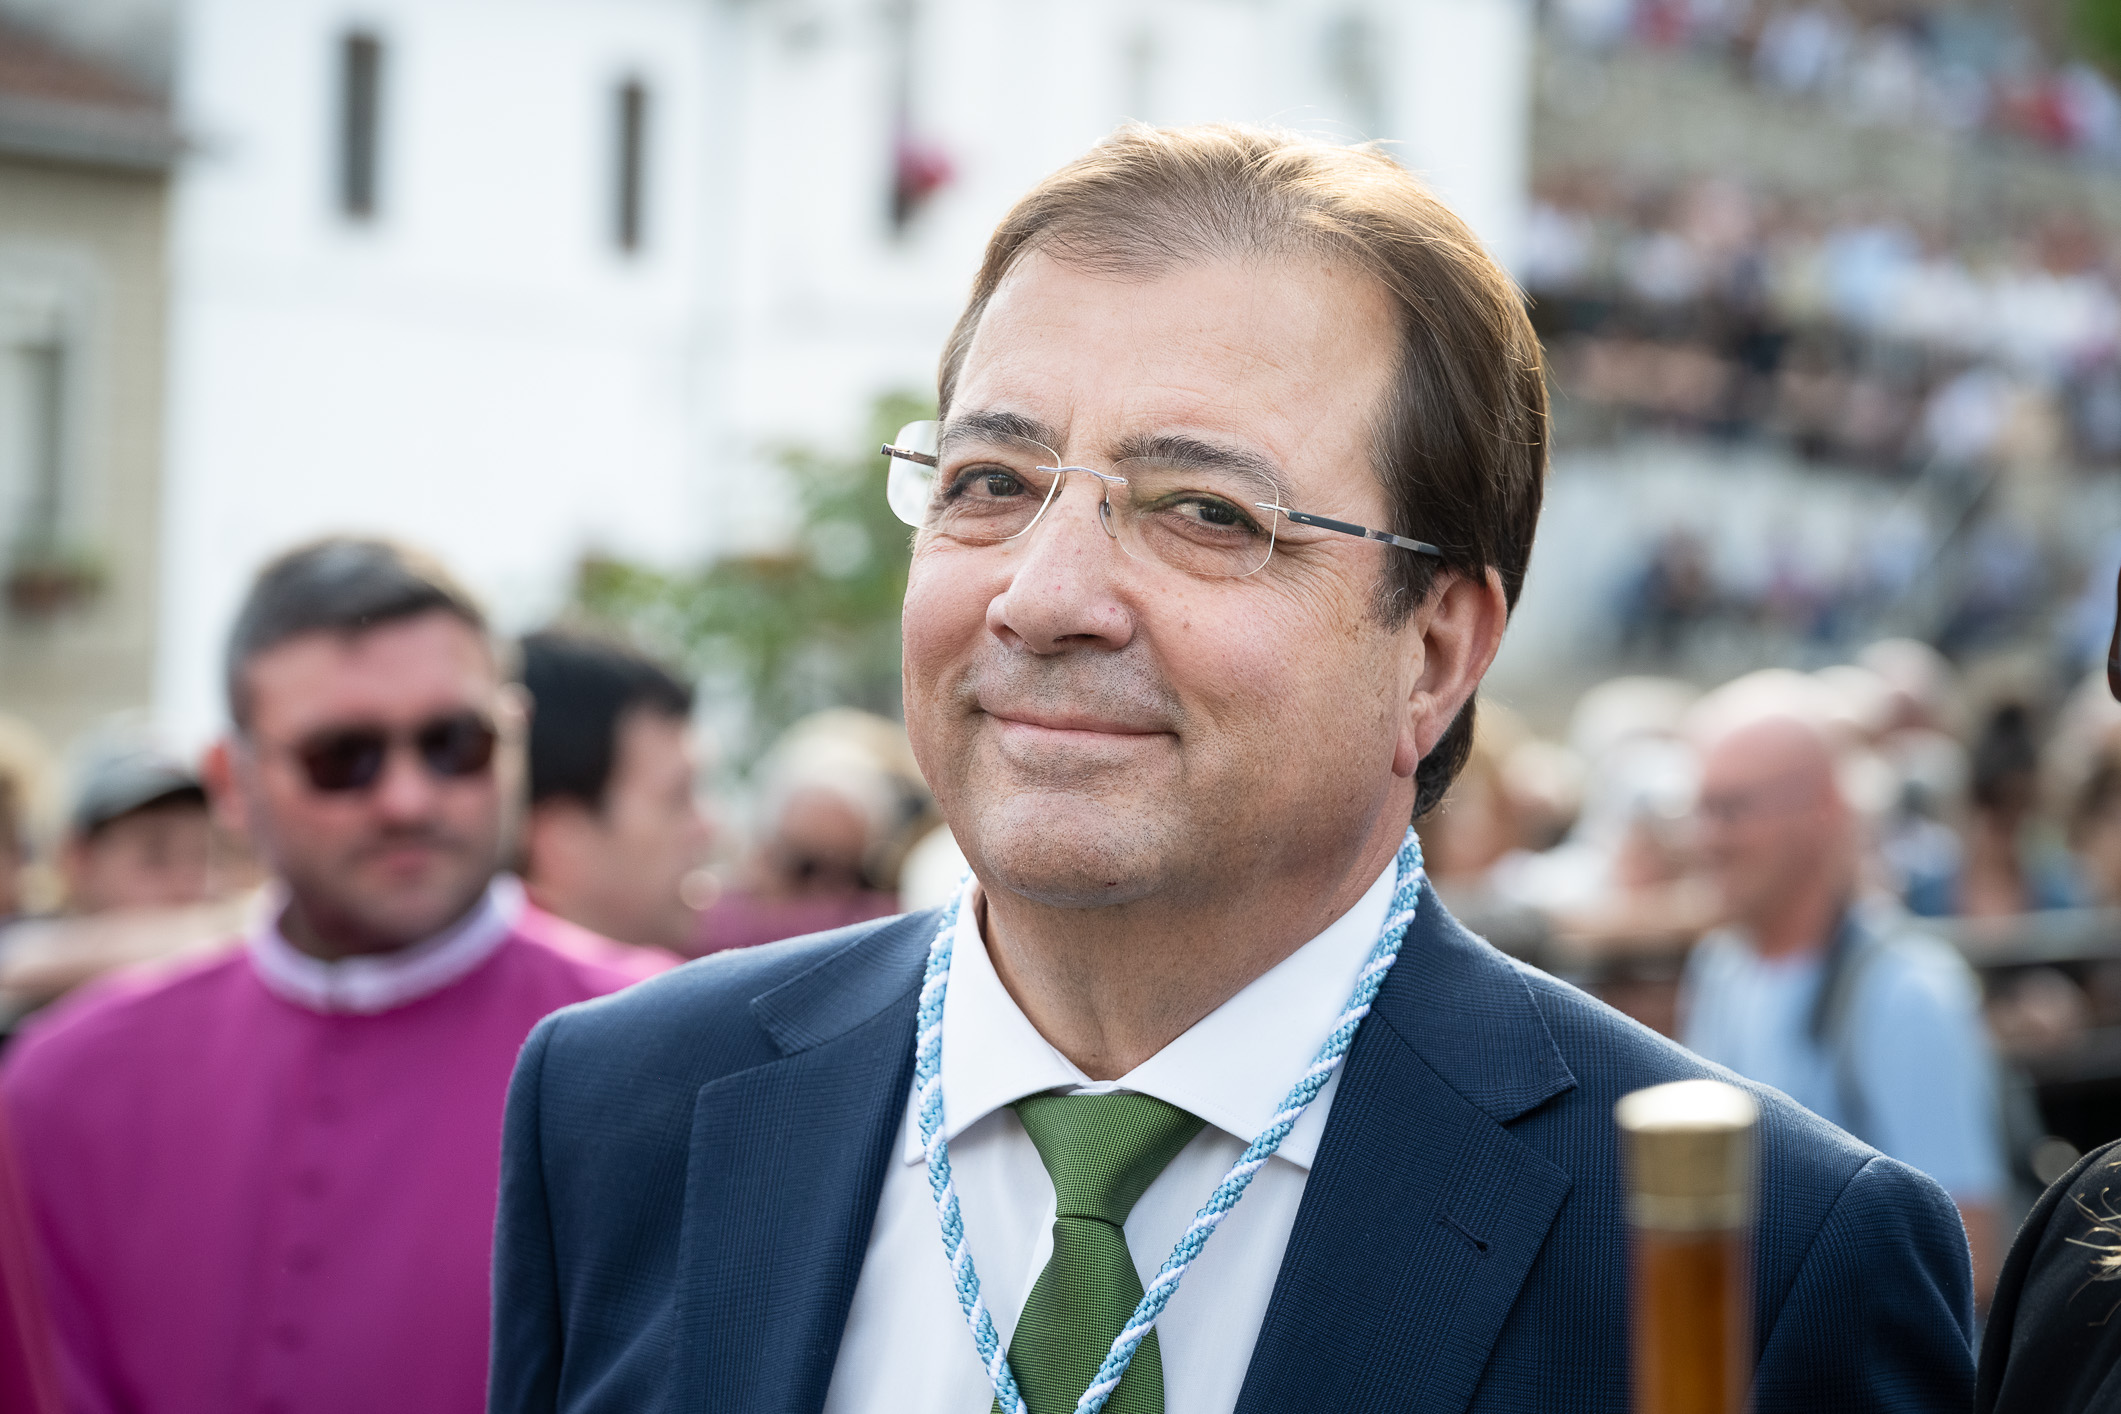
575,394,935,767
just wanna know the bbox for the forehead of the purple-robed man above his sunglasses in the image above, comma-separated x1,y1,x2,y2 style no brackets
244,611,498,736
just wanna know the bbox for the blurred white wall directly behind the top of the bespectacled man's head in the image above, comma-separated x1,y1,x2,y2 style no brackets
732,0,1531,526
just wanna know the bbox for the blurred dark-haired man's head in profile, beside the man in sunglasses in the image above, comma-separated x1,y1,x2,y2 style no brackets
522,632,715,954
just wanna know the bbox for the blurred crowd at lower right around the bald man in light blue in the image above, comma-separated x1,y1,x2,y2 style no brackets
1423,640,2121,1305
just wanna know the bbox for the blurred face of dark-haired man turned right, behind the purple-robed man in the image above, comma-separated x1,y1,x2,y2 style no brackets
530,708,715,952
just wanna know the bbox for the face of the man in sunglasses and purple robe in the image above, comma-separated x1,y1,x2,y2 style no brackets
233,613,505,952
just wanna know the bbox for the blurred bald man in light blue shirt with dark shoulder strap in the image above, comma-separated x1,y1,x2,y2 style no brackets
1680,714,2004,1300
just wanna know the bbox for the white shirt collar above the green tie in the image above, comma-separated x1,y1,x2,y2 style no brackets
899,861,1398,1170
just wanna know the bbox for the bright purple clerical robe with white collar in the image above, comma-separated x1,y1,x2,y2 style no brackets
0,880,670,1414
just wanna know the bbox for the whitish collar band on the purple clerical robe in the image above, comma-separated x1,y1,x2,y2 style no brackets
248,873,524,1015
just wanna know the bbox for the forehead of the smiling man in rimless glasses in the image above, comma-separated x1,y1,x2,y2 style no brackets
950,252,1398,473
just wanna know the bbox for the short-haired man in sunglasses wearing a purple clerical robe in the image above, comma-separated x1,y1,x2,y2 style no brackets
0,538,662,1414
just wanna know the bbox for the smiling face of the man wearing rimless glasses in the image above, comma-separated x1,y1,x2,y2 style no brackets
904,254,1421,905
